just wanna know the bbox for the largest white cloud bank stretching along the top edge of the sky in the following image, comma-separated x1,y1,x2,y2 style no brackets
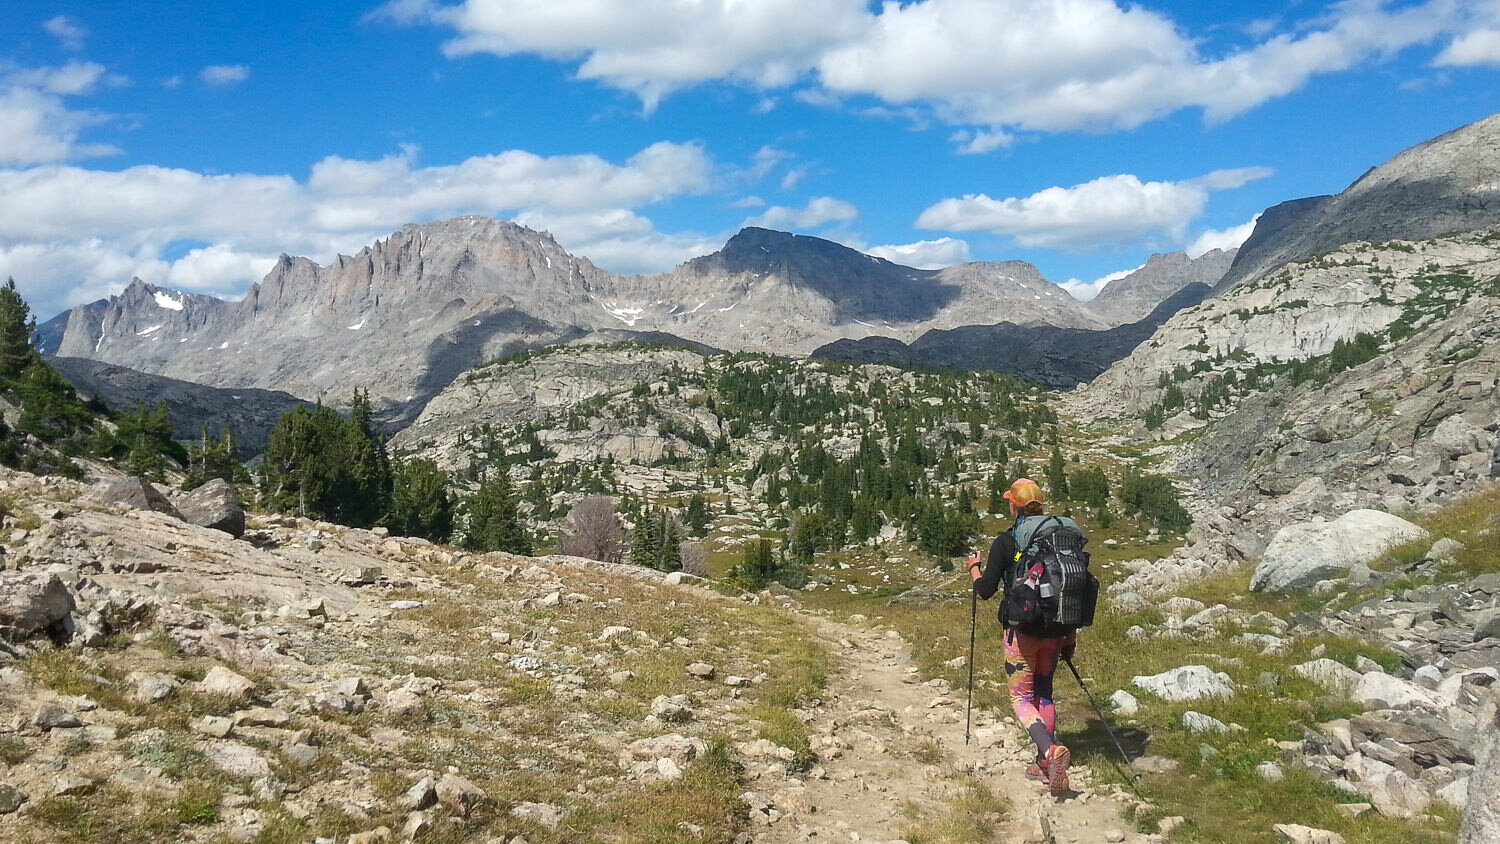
375,0,1497,132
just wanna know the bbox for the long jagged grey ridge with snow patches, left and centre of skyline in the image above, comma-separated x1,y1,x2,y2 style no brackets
44,217,1128,418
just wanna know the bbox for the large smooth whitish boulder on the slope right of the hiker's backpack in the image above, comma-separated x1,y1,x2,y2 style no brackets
1250,510,1428,592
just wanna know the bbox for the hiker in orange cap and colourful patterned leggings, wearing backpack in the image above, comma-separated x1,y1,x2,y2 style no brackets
969,478,1098,798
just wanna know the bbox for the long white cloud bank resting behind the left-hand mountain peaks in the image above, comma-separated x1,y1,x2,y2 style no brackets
0,143,717,316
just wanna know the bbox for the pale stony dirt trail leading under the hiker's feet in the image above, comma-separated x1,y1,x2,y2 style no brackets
752,616,1160,844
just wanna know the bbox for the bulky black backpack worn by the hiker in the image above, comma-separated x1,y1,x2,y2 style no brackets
1001,516,1100,636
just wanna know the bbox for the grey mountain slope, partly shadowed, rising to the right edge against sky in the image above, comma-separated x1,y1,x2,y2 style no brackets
1221,108,1500,288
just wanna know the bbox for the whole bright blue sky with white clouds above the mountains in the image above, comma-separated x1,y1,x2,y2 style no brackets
0,0,1500,318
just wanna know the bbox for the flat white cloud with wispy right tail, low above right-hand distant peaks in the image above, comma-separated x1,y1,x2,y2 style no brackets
917,168,1271,249
